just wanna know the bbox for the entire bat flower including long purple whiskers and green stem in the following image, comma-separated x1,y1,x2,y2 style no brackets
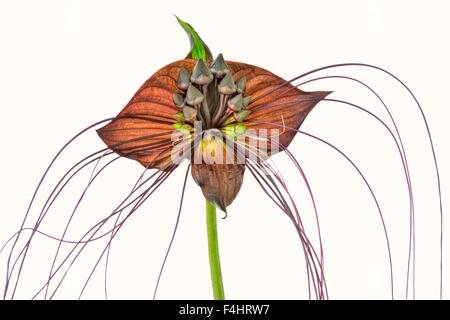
0,15,443,302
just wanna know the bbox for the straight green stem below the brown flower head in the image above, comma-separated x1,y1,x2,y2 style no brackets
206,201,225,300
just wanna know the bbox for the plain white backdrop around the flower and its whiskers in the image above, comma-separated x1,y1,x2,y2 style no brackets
0,0,450,299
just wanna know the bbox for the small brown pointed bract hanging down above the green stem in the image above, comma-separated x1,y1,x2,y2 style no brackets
191,163,245,212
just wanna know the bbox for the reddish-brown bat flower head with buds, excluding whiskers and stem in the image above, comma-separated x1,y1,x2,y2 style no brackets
98,21,330,211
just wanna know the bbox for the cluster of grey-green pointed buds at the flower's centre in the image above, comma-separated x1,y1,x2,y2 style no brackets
173,54,250,136
